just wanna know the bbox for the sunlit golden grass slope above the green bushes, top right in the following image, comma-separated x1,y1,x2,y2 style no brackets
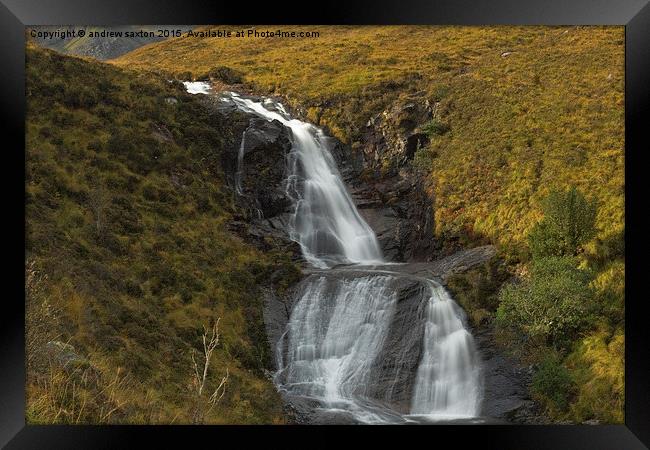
114,26,624,254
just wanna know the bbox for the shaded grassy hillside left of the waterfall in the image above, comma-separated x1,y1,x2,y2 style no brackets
26,46,293,423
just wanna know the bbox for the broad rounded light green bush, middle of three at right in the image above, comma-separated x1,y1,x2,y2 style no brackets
497,257,593,347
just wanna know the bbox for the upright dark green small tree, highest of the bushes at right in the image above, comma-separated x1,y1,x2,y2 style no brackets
528,187,597,258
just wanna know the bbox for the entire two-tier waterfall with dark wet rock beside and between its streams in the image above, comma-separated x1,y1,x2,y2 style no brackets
186,83,540,423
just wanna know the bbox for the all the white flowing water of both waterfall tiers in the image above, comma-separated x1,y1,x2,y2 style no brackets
188,85,481,423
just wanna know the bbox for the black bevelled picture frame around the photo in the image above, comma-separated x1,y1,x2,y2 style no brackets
0,0,650,449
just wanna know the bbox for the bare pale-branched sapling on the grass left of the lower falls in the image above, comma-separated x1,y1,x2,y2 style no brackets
191,318,229,424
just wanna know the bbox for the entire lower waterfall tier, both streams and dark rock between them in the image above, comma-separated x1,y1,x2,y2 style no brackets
276,271,482,423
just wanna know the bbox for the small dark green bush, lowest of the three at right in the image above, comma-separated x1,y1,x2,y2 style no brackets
531,353,576,414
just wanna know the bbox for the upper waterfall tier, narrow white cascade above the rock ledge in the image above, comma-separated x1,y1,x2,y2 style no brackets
224,93,383,268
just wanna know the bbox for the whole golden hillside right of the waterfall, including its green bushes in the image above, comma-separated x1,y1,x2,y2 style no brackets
112,26,625,423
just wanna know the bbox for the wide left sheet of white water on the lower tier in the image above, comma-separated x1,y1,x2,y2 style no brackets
279,276,397,421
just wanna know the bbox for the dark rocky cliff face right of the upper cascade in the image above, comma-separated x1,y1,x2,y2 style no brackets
344,94,438,262
